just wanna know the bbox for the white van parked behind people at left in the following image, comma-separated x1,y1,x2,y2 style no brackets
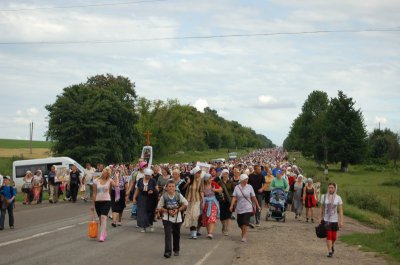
12,157,85,190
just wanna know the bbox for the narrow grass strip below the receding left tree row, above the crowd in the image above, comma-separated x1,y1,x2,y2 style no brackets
153,149,251,163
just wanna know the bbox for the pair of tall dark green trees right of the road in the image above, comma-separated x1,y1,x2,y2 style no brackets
284,91,367,170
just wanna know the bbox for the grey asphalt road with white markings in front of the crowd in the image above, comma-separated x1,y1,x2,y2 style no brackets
0,202,241,265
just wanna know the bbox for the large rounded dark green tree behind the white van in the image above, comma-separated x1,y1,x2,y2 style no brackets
46,75,139,163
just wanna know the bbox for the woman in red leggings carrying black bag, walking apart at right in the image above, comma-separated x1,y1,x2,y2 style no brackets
319,182,343,258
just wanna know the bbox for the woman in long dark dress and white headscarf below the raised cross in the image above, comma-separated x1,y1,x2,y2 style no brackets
133,168,157,233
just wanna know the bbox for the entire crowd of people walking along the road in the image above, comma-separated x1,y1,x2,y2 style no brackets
0,148,343,258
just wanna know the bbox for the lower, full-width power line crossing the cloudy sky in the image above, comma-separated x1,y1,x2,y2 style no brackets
0,27,400,45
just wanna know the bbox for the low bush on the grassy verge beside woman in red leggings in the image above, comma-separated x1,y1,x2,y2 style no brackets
345,191,391,218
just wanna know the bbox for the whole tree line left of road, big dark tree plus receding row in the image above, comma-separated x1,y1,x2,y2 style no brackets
46,74,274,163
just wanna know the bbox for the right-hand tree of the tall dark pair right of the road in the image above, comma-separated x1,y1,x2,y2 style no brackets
326,91,367,171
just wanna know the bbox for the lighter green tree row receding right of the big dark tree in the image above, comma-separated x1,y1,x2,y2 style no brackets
137,98,274,156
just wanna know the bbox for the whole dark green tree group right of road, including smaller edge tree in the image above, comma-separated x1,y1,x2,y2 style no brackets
283,91,400,171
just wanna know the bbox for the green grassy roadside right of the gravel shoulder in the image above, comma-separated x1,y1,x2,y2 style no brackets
290,153,400,264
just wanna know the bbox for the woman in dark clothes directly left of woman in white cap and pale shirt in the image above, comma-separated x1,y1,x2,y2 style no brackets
218,169,235,236
